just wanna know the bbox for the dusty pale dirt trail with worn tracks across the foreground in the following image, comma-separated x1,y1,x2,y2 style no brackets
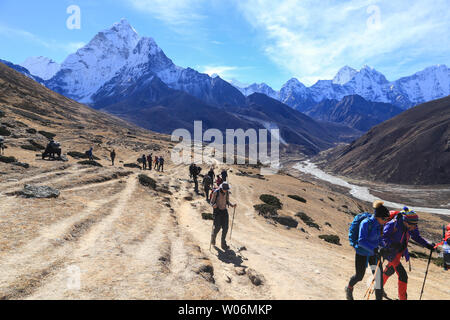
0,156,449,299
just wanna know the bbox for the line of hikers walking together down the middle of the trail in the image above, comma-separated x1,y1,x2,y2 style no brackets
189,163,237,250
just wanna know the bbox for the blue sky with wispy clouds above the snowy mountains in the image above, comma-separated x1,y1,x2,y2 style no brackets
0,0,450,90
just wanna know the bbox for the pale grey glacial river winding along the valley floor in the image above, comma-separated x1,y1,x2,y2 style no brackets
293,161,450,215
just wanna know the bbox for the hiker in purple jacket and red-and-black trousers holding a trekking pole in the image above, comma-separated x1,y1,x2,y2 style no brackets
382,207,435,300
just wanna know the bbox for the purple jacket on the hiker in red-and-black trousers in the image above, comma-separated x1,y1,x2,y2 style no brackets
381,214,429,261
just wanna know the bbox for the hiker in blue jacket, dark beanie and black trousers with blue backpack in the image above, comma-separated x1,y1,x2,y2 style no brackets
345,201,389,300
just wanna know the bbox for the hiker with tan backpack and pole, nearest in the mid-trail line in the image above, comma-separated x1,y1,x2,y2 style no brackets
211,182,237,250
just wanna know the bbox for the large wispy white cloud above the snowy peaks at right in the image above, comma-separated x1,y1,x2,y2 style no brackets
235,0,450,84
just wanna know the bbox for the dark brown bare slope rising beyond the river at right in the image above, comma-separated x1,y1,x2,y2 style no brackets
326,97,450,185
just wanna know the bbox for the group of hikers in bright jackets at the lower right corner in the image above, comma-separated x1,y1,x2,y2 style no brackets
345,201,450,300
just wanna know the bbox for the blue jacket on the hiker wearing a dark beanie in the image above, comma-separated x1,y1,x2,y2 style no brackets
355,215,381,257
